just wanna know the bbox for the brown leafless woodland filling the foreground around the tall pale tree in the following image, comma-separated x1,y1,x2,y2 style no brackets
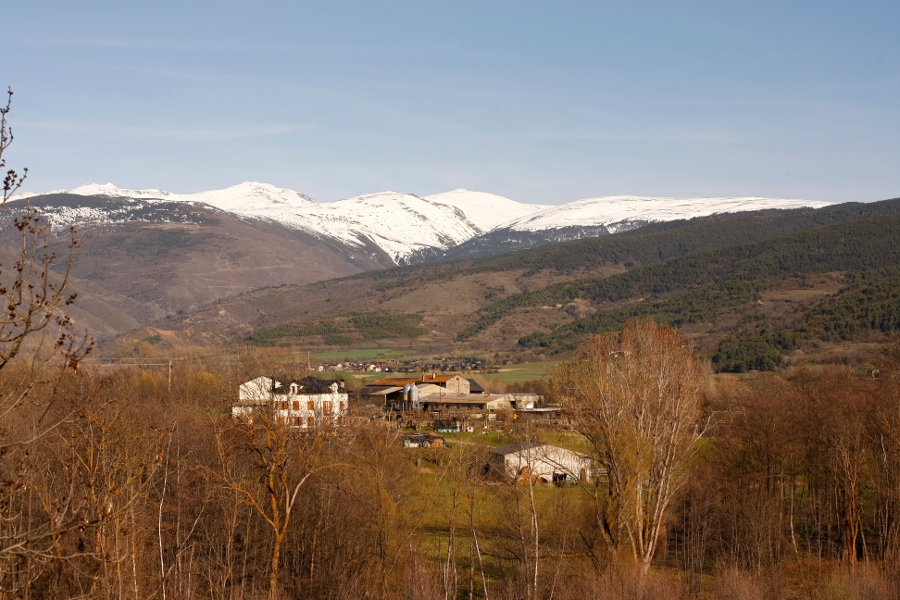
0,344,900,599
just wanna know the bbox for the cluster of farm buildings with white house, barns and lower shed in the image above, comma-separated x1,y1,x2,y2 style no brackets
232,360,576,485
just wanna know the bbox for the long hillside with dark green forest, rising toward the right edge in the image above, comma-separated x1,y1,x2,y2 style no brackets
188,200,900,371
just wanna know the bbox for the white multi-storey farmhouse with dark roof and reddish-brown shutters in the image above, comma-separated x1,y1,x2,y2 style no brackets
231,377,349,430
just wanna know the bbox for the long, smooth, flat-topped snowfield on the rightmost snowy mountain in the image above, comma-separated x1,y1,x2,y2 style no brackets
504,196,830,233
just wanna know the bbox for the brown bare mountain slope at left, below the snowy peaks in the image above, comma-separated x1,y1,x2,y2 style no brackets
0,194,393,339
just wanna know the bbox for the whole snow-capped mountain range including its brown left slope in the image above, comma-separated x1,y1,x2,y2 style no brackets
0,182,823,338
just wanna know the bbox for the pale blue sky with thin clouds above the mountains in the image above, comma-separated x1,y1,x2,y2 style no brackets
0,0,900,204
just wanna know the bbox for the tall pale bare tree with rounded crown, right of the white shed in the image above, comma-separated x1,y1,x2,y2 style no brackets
551,320,702,572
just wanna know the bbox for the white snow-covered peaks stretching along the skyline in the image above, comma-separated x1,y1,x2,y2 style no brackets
15,182,828,264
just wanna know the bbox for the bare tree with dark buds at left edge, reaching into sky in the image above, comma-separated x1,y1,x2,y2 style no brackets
0,90,92,559
